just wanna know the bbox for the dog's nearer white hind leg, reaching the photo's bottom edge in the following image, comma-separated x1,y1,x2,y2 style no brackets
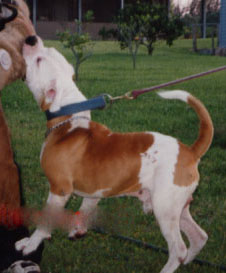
152,191,187,273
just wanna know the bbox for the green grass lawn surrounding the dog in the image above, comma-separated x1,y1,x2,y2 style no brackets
2,40,226,273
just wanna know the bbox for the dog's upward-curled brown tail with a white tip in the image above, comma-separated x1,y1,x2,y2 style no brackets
158,90,214,158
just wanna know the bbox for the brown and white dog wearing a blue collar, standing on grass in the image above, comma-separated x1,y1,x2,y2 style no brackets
16,36,213,273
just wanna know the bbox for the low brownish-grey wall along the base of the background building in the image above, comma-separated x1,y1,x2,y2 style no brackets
36,21,116,40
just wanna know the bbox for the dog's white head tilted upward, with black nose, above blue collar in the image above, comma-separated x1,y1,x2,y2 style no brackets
23,36,81,111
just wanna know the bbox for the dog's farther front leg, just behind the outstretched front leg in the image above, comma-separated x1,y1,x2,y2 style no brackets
69,198,100,239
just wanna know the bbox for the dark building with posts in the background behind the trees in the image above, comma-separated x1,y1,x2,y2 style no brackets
27,0,170,39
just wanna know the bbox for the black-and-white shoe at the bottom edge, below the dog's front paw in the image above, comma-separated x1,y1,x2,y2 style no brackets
4,261,41,273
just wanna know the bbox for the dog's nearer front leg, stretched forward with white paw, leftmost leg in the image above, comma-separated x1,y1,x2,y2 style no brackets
15,192,69,255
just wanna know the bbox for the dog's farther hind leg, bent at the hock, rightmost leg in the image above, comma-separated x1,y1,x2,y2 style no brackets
180,205,208,264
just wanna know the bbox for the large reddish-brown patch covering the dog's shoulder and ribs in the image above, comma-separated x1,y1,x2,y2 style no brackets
41,122,154,197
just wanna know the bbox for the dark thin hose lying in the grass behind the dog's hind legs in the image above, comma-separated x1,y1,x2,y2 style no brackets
93,228,226,272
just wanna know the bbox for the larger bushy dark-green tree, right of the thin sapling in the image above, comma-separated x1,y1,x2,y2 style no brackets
116,2,183,68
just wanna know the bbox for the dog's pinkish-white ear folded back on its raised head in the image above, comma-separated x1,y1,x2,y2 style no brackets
45,79,62,112
